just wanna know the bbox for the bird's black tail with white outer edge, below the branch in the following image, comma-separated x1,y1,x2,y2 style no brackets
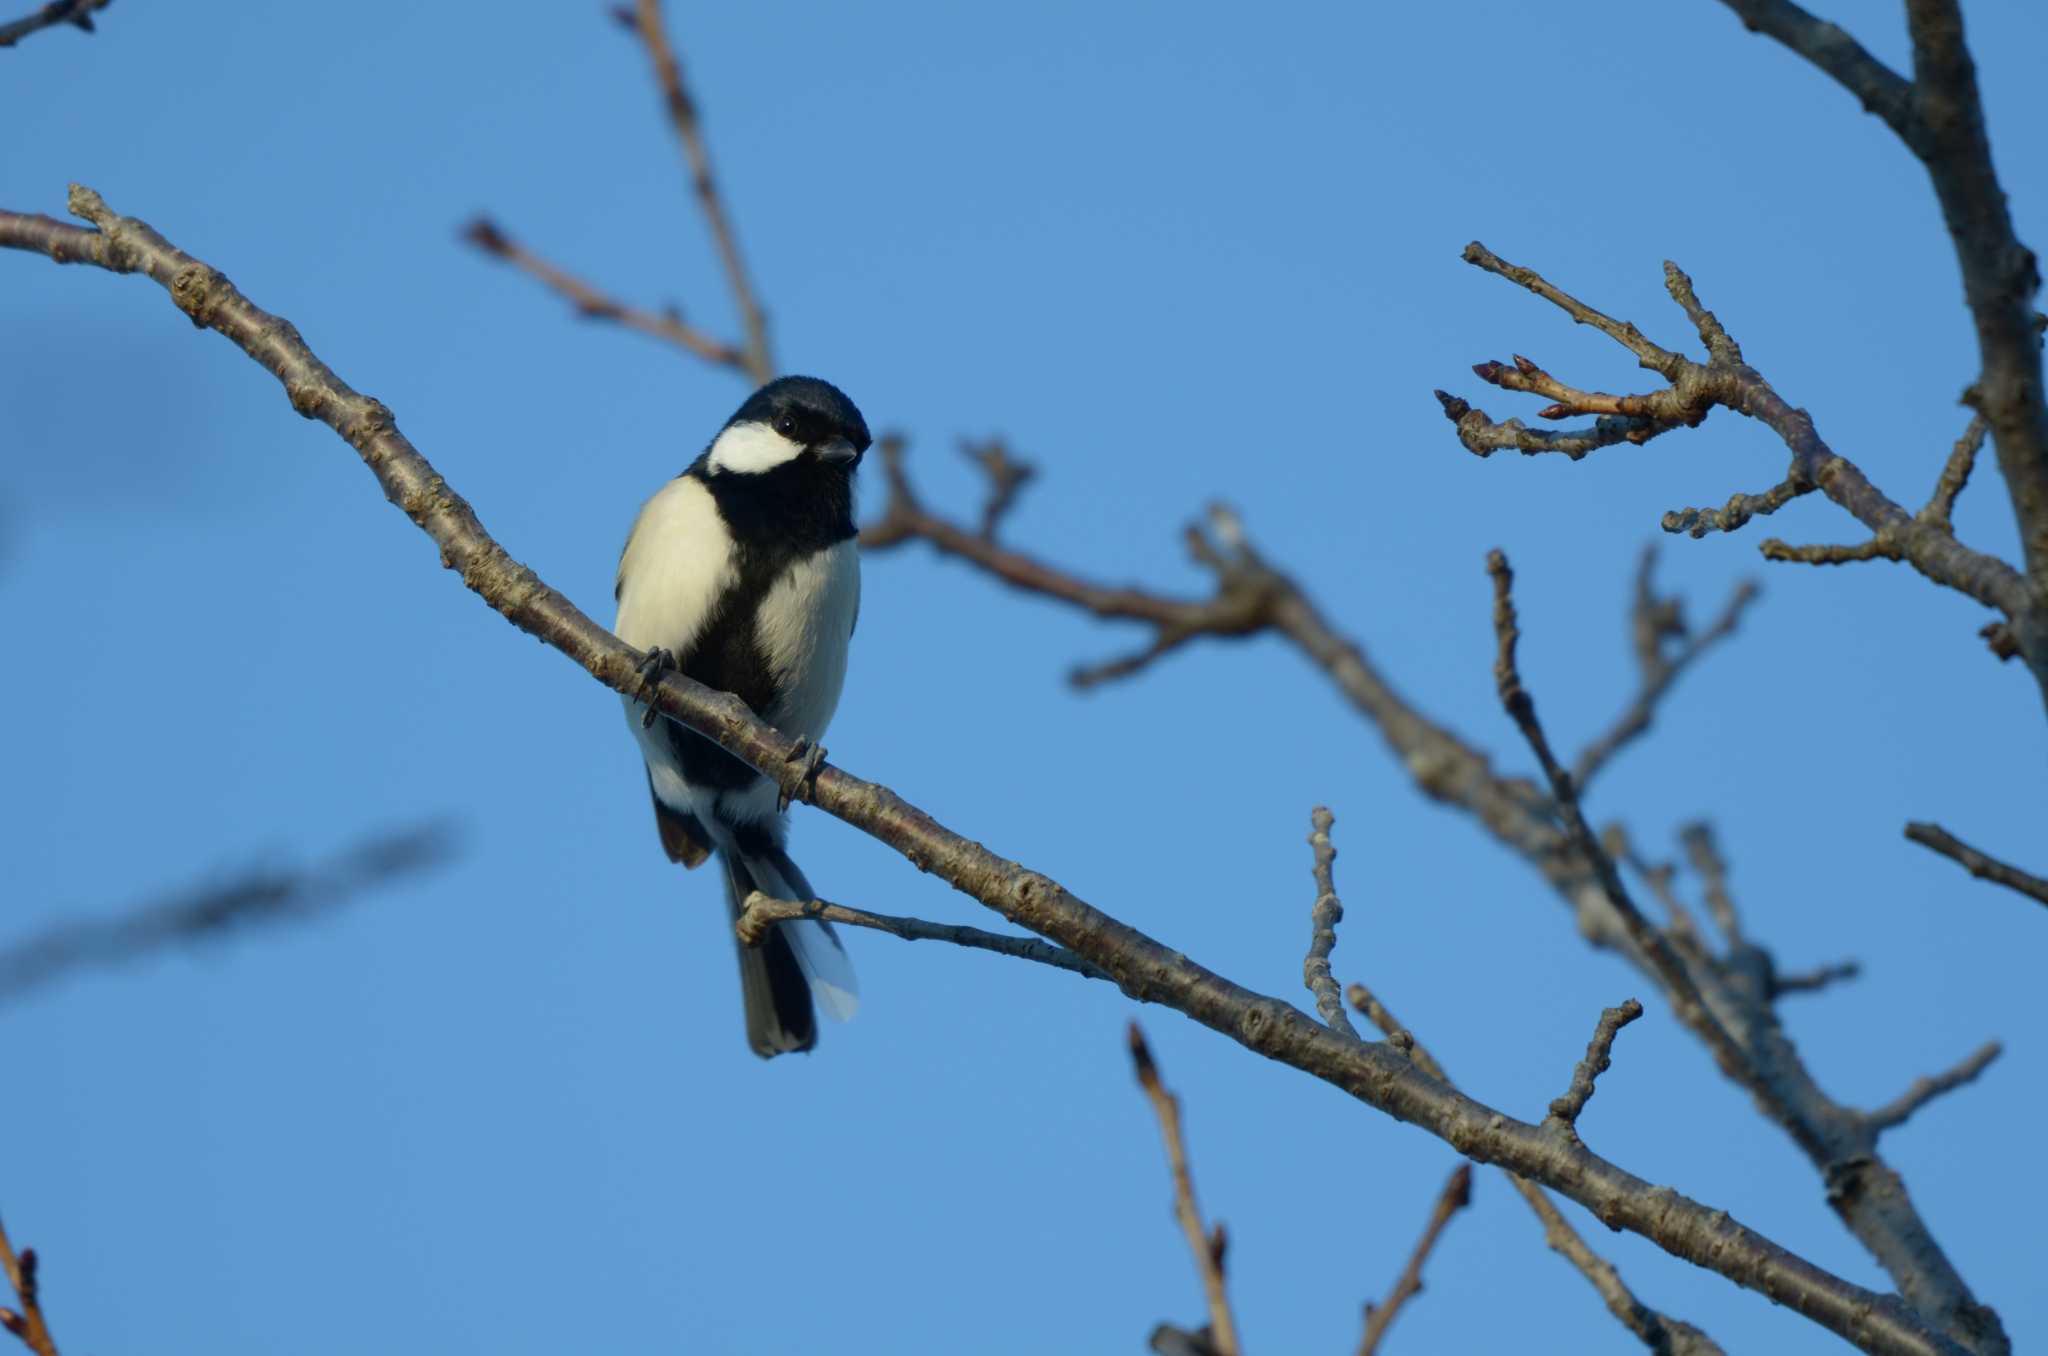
719,846,860,1059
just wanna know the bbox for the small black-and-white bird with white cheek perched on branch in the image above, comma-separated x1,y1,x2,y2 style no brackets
612,377,870,1059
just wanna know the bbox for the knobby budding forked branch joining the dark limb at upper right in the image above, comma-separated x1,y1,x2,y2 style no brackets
1438,240,2048,692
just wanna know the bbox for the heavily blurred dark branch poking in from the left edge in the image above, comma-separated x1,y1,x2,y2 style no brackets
0,823,455,1004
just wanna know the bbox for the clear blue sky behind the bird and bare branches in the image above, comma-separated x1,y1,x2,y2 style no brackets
0,0,2048,1356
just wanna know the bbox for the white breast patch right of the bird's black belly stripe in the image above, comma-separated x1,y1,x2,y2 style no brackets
754,541,860,739
